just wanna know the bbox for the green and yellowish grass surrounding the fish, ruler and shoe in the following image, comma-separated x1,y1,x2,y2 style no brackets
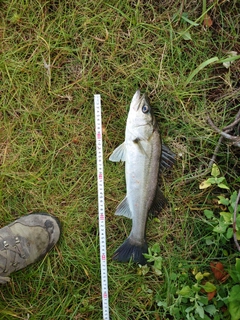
0,0,240,320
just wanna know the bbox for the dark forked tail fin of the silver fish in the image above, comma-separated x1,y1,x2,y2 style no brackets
113,237,148,265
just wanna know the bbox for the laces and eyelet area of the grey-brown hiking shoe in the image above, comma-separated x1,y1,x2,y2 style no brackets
0,237,26,276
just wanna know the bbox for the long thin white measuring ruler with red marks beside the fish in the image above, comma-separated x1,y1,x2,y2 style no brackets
94,94,110,320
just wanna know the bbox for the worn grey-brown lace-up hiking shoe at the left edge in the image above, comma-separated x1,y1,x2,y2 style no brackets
0,213,60,284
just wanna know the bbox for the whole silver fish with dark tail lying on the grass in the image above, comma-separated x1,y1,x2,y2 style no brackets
109,90,175,265
